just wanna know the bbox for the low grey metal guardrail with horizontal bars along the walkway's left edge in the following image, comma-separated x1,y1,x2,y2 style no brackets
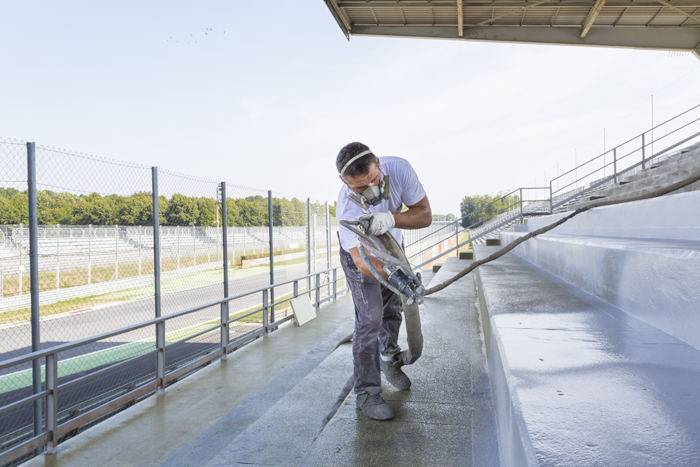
0,267,346,465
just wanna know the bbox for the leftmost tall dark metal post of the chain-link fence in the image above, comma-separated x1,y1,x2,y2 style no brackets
27,143,42,436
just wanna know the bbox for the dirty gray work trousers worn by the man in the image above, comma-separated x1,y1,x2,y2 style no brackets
340,249,402,394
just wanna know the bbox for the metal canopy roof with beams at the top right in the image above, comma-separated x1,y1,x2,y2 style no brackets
325,0,700,58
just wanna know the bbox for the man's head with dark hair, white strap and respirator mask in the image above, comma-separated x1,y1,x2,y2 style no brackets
335,142,381,193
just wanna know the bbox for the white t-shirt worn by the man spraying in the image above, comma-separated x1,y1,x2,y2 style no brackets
336,157,425,251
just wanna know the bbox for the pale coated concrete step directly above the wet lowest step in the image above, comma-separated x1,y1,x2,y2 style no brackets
502,232,700,348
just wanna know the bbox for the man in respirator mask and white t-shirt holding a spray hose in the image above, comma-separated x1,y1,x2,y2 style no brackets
335,143,432,420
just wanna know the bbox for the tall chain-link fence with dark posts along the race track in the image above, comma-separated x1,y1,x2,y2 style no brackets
0,139,344,464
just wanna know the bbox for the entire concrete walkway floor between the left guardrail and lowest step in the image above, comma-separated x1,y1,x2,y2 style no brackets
29,260,498,466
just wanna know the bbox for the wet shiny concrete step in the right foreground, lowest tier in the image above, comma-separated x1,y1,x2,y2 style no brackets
475,247,700,465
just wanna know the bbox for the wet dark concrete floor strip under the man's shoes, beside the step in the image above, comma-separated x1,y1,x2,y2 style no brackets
304,258,499,466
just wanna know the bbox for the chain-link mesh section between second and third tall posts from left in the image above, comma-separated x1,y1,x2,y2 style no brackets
158,169,224,368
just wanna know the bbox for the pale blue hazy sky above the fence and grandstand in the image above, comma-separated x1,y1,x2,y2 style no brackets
0,0,700,212
